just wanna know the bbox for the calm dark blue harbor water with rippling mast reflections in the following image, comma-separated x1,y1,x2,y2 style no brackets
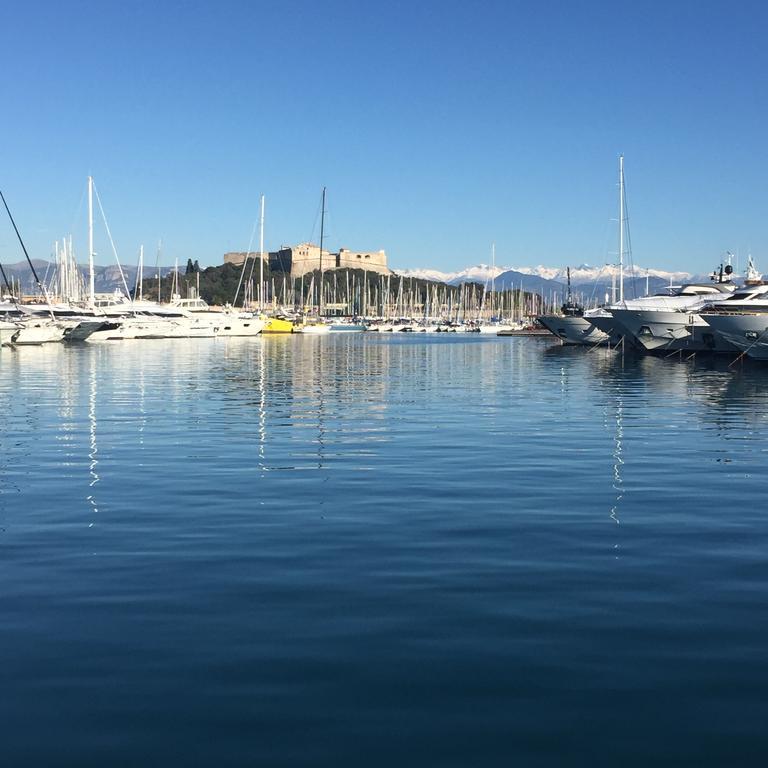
0,334,768,766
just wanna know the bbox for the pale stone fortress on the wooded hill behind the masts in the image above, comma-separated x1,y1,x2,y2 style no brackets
224,243,391,278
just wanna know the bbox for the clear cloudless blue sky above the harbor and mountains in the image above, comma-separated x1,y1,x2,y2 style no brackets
0,0,768,272
